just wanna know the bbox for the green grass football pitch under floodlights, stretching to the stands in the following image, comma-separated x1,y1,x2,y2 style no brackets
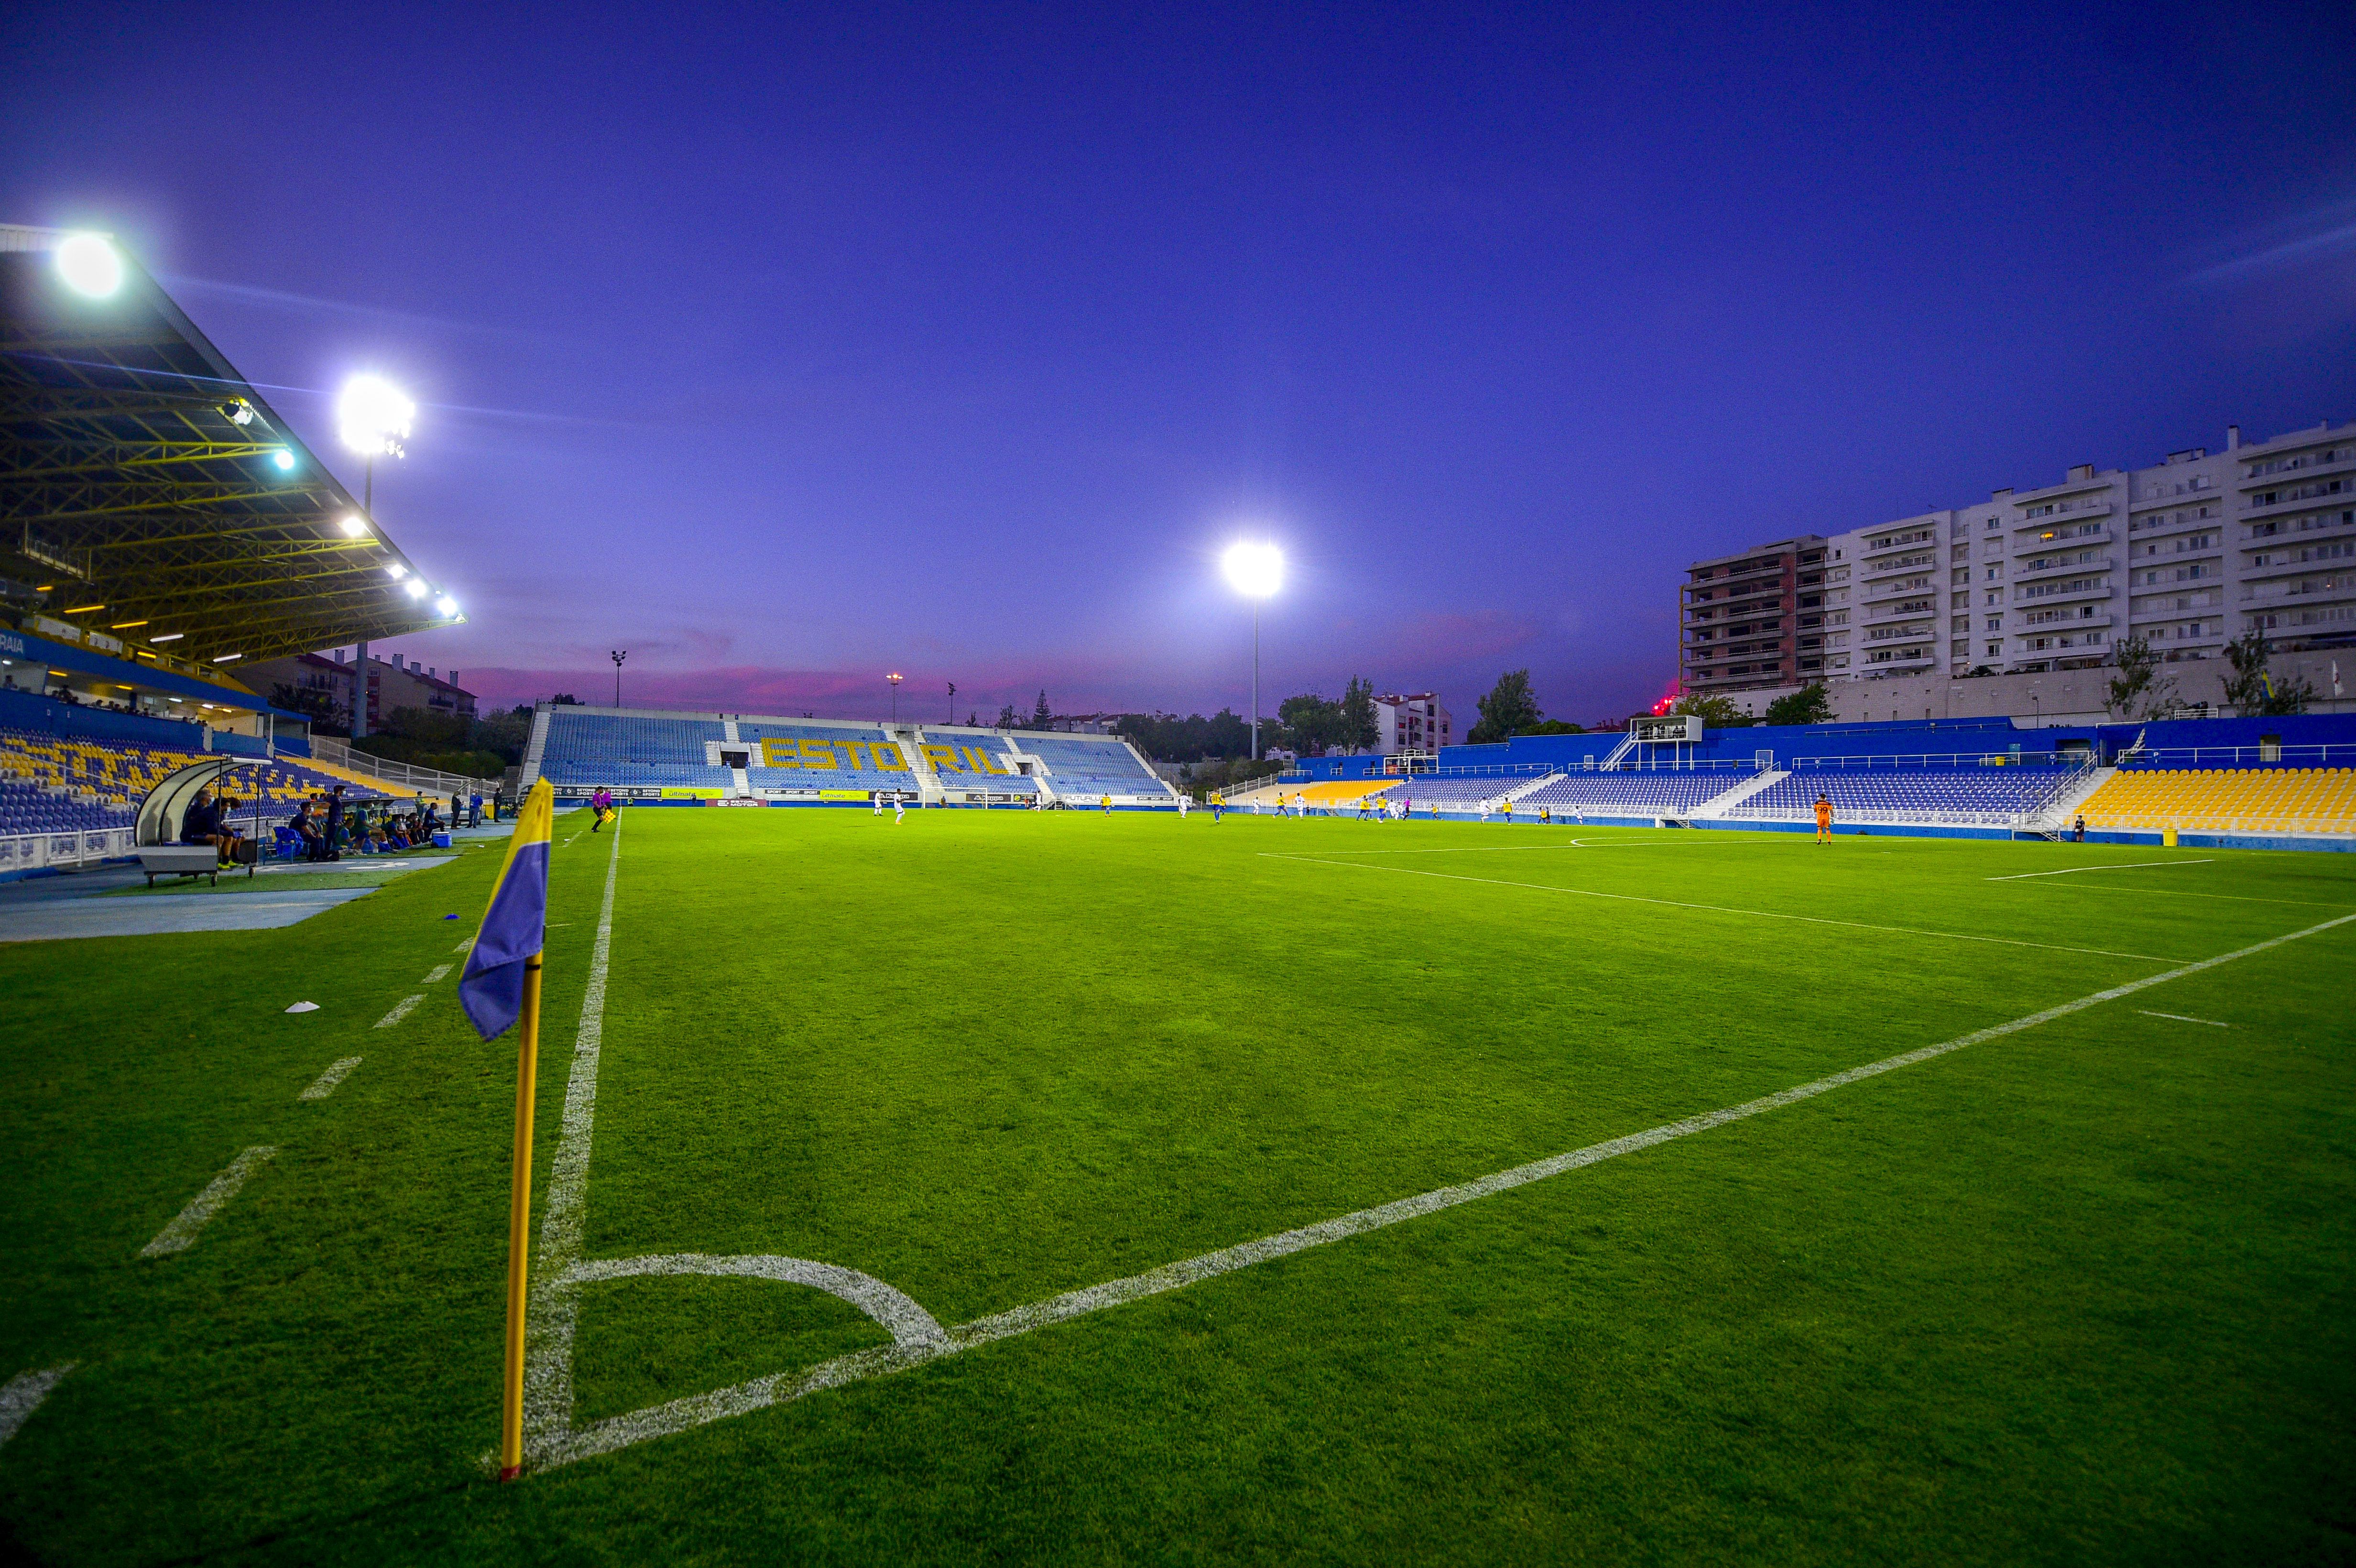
0,810,2356,1563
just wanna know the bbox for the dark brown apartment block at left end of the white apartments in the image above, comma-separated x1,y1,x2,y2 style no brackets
1678,534,1828,692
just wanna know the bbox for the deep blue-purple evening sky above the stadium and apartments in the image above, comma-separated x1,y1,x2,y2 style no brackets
0,2,2356,723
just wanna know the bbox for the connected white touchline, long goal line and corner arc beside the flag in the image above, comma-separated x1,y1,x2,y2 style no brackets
523,890,2356,1469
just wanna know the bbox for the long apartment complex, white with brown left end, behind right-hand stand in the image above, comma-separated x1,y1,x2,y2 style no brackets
1680,422,2356,690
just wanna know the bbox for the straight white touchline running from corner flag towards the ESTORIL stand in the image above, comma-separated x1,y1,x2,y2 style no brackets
523,819,622,1458
